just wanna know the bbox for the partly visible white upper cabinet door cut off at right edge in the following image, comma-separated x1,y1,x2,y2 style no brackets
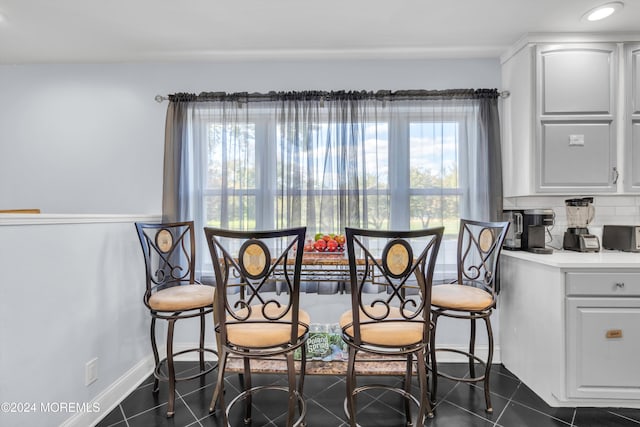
624,44,640,192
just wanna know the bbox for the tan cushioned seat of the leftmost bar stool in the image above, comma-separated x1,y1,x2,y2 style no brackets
149,285,215,311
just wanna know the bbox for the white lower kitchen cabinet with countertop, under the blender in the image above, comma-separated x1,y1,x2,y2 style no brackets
498,251,640,408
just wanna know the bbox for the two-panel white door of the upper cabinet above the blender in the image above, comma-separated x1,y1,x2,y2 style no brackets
535,43,618,194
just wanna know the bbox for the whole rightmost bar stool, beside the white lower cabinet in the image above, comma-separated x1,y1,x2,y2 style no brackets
430,219,509,413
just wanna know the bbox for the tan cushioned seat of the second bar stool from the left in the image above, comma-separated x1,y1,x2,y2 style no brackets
227,305,311,348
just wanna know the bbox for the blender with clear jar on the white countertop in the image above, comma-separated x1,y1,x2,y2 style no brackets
562,197,600,252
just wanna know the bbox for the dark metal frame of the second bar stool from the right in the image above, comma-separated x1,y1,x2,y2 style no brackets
342,227,444,427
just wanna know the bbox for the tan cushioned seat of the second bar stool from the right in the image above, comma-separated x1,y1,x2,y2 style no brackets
340,306,424,347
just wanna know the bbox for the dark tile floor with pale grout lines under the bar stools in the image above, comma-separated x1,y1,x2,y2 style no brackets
98,362,640,427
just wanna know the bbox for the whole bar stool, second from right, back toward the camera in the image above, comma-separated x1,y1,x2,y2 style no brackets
340,227,444,427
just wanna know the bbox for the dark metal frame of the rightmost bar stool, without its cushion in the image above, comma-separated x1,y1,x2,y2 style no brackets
430,219,509,413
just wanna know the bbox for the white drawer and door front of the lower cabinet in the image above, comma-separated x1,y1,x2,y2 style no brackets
566,272,640,399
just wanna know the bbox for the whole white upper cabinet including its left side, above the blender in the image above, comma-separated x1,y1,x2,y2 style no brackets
502,42,620,197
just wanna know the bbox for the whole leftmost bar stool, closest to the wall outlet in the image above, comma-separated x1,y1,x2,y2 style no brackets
135,221,217,417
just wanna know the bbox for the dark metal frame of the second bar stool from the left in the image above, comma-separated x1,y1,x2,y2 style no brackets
204,227,309,426
